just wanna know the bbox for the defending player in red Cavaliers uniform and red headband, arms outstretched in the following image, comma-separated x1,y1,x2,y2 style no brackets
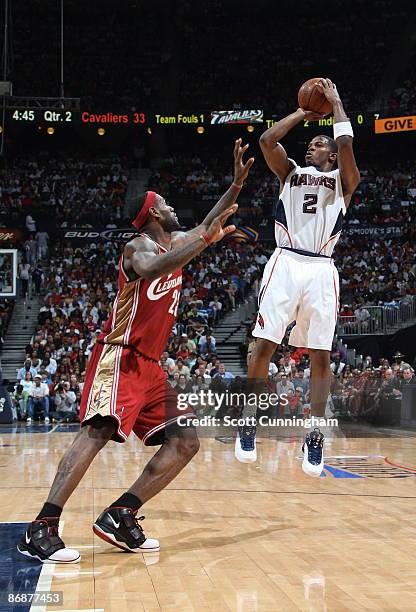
18,139,254,563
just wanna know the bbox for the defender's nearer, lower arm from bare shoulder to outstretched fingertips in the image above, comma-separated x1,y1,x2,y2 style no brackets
124,204,238,280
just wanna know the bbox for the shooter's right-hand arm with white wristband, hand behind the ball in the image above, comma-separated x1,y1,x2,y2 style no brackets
318,79,360,206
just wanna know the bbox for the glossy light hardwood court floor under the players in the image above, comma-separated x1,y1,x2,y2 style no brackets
0,431,416,612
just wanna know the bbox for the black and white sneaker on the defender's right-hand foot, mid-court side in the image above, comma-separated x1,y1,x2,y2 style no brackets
92,508,160,552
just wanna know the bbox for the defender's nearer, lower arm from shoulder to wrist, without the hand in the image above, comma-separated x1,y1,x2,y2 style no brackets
123,235,207,280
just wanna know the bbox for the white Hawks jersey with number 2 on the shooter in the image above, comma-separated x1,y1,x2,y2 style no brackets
274,159,346,257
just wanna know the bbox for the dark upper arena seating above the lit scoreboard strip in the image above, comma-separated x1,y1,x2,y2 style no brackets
10,0,407,113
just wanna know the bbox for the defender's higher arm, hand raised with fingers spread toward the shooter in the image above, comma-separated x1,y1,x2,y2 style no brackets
172,138,254,246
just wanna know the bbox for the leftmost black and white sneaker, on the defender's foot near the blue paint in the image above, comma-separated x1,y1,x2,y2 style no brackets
17,517,81,563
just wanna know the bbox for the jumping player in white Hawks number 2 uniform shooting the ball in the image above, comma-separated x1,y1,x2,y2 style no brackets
235,79,360,476
